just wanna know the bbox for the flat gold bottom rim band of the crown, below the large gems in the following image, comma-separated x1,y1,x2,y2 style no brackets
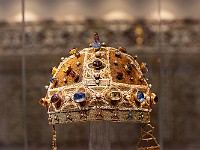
49,108,150,124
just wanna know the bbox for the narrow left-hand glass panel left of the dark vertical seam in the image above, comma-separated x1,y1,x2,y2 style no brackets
0,0,24,150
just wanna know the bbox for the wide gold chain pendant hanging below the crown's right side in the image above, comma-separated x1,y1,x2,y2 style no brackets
136,124,160,150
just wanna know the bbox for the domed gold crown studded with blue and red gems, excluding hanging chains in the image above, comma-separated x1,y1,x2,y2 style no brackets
40,33,158,149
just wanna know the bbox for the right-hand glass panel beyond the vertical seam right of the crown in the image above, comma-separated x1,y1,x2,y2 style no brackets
160,0,200,149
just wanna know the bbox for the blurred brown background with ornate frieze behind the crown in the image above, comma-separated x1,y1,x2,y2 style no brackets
0,0,200,150
